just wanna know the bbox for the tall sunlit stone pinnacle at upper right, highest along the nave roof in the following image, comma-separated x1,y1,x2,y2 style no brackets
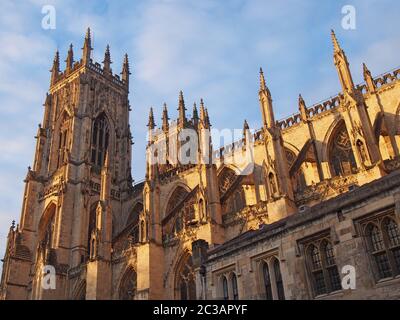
331,30,355,95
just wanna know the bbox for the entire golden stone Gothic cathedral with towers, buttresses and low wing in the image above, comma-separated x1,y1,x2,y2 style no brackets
0,29,400,300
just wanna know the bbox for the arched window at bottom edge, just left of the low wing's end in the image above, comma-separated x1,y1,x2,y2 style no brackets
177,257,196,300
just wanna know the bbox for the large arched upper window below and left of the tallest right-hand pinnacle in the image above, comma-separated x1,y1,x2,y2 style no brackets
329,122,357,176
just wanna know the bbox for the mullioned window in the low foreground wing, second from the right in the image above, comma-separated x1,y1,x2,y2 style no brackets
307,238,341,296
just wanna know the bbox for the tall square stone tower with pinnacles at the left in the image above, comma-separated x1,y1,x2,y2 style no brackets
1,29,132,299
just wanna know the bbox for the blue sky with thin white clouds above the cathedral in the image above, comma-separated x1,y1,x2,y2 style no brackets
0,0,400,264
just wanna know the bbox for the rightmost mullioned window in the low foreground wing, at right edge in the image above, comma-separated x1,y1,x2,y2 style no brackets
365,217,400,280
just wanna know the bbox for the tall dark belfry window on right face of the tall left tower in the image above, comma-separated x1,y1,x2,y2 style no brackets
91,114,110,167
